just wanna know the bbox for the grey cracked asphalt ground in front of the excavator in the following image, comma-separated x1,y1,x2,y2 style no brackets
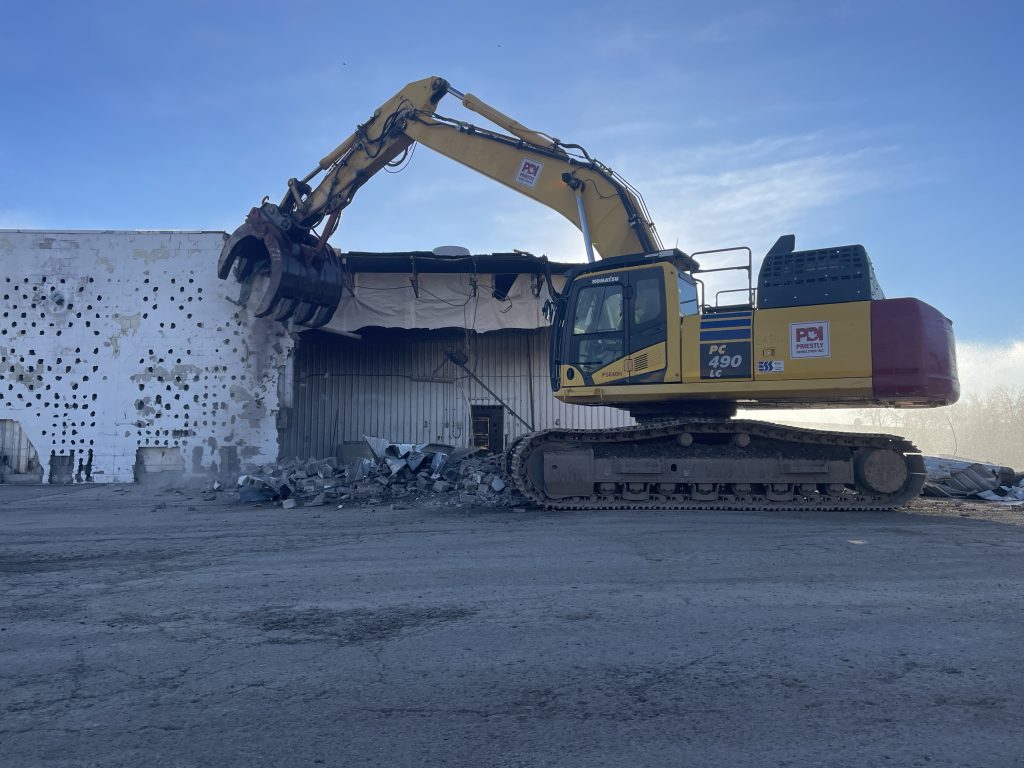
0,485,1024,768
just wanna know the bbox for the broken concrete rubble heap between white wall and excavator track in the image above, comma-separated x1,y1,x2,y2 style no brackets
239,437,527,509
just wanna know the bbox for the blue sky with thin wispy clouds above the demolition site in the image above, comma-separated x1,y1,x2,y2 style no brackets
0,0,1024,342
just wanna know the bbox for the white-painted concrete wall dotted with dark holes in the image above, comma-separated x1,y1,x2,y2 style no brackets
0,230,292,482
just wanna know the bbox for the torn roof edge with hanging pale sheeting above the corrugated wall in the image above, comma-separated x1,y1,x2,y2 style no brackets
322,251,578,335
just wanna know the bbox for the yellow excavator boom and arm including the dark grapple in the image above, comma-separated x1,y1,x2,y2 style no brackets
218,77,662,328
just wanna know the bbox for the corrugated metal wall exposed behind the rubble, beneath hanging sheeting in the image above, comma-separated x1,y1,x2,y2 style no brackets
281,329,632,457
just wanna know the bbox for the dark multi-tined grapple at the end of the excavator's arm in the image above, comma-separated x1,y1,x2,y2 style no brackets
217,208,344,328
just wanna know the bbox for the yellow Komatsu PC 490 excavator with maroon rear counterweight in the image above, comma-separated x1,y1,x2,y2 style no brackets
218,77,959,510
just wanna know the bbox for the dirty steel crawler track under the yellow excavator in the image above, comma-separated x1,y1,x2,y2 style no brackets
506,418,925,511
